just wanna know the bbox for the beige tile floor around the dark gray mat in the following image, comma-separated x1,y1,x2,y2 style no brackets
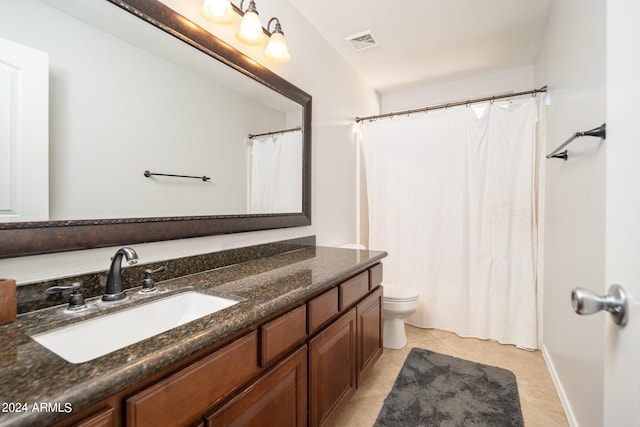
335,325,568,427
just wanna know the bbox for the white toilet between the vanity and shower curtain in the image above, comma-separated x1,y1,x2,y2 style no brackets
382,284,418,349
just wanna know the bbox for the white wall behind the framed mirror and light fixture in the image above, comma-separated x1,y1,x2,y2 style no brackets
0,0,379,283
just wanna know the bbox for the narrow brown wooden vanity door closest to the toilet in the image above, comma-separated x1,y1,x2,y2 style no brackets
356,287,383,386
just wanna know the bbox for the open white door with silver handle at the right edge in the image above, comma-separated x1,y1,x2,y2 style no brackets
603,0,640,427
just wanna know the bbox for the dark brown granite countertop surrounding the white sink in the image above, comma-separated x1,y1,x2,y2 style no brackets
0,247,386,426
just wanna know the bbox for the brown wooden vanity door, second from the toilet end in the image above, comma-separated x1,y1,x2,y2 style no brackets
309,308,357,426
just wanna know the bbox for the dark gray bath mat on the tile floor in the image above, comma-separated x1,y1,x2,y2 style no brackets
375,348,524,427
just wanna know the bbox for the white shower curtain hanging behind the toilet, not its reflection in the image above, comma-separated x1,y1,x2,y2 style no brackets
362,98,537,348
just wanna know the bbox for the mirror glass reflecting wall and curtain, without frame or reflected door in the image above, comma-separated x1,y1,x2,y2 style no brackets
0,0,302,220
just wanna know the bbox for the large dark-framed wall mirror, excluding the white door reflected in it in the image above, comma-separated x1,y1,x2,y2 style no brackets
0,0,311,257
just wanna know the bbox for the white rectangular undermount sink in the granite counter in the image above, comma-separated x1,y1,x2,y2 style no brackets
32,291,238,363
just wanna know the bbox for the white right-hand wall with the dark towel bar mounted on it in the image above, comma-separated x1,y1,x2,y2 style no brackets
535,0,606,427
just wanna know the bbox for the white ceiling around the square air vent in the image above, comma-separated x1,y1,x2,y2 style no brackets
289,0,552,94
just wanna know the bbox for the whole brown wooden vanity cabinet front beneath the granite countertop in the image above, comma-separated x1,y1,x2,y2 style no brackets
59,265,383,427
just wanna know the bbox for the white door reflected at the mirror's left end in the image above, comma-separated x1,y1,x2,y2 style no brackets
0,38,49,222
